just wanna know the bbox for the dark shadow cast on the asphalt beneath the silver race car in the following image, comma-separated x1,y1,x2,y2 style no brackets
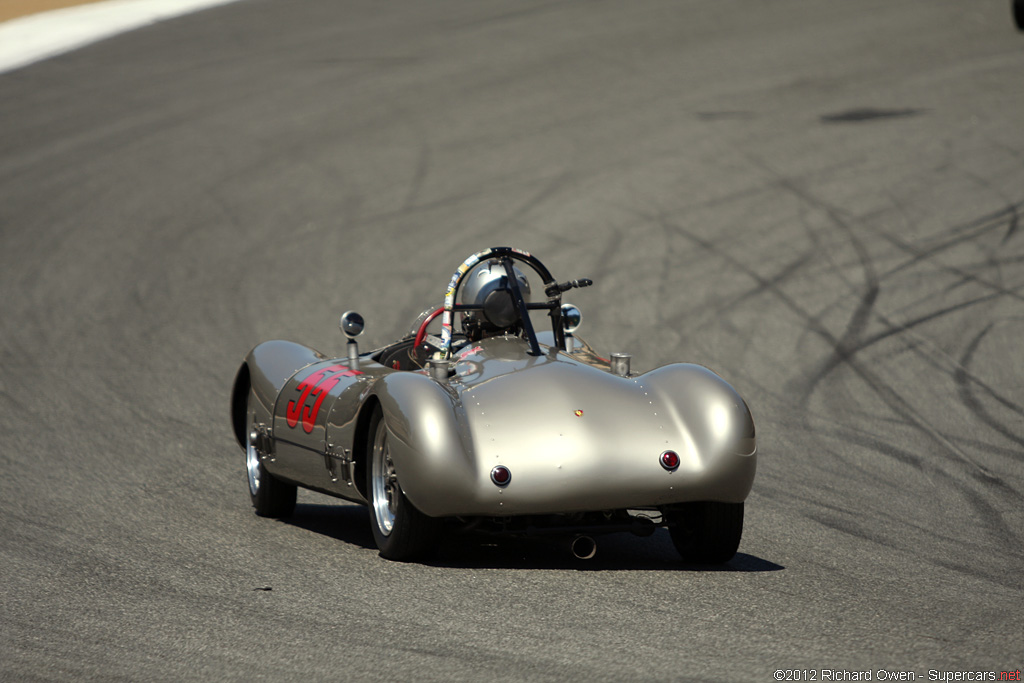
283,503,785,572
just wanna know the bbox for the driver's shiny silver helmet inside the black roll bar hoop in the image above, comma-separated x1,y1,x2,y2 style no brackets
460,261,529,339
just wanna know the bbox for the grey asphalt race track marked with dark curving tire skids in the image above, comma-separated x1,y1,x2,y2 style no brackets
0,0,1024,681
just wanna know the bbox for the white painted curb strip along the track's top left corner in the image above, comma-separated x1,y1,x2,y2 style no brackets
0,0,243,73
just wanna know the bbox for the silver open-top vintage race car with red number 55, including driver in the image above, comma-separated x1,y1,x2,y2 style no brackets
231,247,757,563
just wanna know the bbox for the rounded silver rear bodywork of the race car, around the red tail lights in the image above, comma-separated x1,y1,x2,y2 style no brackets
380,338,756,516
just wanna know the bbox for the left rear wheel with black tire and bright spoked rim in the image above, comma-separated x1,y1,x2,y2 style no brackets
366,405,441,562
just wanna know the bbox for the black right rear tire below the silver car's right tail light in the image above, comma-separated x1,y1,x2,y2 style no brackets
670,503,743,564
